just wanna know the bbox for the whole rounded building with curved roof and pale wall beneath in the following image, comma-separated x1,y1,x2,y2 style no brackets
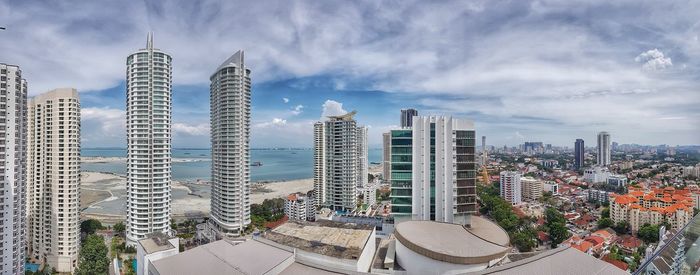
394,216,511,274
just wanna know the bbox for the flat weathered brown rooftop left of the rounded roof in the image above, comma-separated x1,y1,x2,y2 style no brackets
265,221,374,259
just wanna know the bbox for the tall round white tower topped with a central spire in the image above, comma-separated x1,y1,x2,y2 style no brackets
126,34,172,245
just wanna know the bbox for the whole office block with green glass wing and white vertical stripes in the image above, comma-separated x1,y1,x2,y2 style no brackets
391,116,476,224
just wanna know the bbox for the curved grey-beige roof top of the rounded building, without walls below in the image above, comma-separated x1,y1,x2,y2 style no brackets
394,216,510,264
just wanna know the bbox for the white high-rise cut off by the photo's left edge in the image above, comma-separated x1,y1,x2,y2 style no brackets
0,63,27,275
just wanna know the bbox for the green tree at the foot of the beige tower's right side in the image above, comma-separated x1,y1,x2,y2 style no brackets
75,234,109,275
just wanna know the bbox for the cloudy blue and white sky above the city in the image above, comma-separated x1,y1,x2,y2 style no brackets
0,0,700,148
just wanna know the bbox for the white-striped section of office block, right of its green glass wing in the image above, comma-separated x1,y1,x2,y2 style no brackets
411,116,476,224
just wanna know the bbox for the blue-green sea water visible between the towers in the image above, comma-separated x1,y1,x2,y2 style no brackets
80,148,382,182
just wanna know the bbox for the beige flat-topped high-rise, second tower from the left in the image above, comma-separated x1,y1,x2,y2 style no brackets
27,88,80,273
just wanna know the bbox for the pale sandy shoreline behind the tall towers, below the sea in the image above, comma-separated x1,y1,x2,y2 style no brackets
80,172,313,221
